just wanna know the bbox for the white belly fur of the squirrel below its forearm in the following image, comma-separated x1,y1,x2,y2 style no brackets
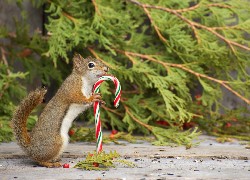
60,104,89,154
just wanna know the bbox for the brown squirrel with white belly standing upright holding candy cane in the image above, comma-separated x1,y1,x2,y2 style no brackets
12,54,109,167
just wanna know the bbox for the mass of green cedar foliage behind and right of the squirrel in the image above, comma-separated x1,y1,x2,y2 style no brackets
0,0,250,147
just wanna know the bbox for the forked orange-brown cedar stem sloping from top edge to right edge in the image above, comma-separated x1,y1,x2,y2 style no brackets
127,0,250,53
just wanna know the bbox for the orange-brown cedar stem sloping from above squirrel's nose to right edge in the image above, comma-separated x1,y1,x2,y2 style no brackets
118,50,250,104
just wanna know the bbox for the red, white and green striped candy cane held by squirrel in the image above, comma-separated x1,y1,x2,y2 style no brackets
93,75,121,153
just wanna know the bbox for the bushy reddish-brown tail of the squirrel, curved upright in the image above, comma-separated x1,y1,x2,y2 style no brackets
12,88,47,149
